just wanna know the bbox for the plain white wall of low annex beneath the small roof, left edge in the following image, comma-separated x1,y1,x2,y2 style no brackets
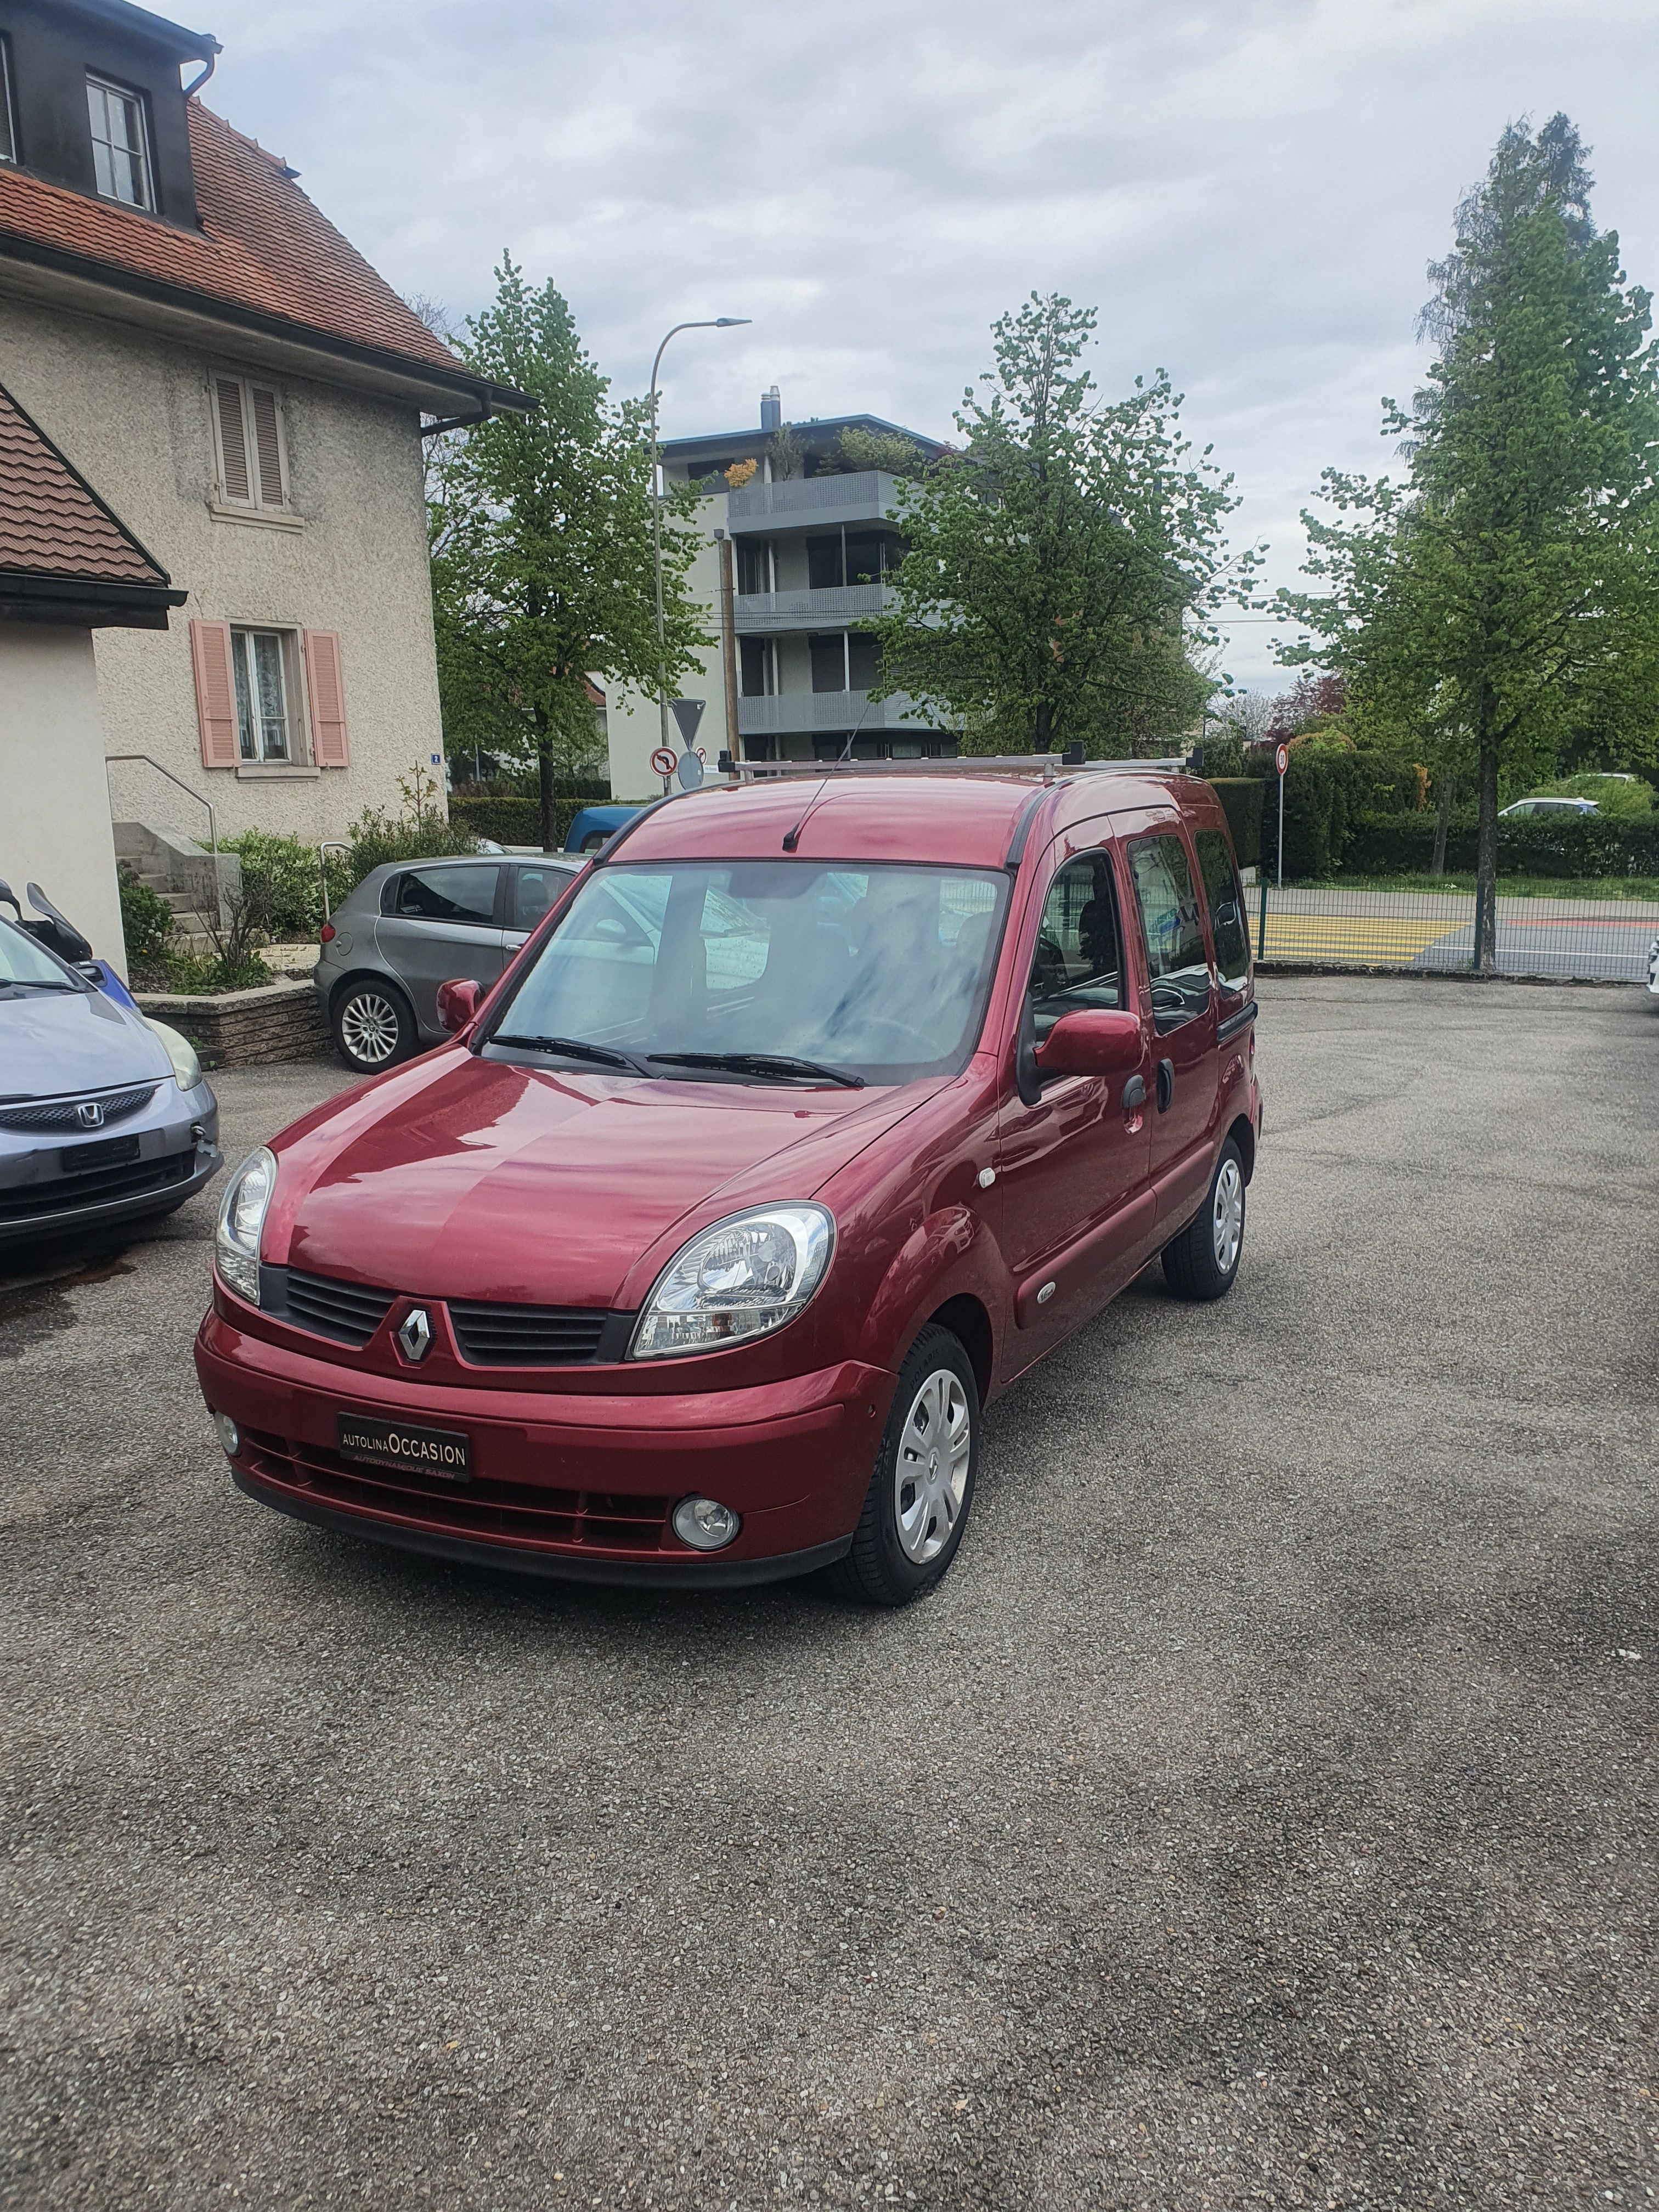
0,622,126,975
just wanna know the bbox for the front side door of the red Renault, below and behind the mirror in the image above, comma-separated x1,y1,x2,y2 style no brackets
995,823,1155,1374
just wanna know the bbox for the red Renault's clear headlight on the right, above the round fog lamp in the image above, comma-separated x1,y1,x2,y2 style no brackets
628,1205,836,1361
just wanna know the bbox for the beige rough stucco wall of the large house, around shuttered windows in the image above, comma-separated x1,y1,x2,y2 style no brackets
0,294,442,840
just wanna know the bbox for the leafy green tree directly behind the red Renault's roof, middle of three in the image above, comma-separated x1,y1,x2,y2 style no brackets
865,292,1256,757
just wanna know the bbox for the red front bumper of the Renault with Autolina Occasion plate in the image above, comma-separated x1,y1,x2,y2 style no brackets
195,1312,894,1588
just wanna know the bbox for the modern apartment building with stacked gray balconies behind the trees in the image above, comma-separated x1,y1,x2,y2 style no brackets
608,385,956,799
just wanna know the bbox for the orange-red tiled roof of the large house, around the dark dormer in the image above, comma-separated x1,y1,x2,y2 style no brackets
0,99,469,378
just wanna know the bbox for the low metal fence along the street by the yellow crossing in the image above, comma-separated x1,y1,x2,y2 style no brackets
1245,881,1659,982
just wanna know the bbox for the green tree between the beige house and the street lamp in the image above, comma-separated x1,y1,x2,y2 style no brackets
429,255,710,847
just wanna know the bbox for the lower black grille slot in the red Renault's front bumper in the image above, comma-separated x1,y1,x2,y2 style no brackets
244,1429,684,1558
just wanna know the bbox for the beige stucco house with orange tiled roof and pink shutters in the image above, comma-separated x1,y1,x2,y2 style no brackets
0,0,529,969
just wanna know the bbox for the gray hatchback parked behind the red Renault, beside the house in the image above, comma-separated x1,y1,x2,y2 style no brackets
317,854,582,1075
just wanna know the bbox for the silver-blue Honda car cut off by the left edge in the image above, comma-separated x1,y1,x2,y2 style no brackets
0,920,219,1245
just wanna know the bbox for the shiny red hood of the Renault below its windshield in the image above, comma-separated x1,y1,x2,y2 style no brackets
263,1046,938,1310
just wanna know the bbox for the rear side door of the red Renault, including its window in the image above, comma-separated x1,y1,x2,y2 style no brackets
1124,821,1221,1241
